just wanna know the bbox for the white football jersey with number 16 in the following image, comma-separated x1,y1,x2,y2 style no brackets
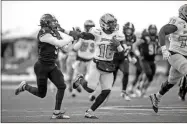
89,28,125,61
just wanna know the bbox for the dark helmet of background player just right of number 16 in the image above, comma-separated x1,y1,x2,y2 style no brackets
123,22,135,36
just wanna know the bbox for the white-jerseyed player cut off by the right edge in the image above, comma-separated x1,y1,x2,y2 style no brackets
150,4,187,112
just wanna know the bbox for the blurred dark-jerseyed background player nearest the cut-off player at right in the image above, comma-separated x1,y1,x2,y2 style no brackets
136,25,159,96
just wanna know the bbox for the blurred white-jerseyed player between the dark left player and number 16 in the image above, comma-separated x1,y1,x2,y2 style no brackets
73,20,95,98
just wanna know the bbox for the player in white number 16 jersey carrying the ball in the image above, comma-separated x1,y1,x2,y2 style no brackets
73,13,124,119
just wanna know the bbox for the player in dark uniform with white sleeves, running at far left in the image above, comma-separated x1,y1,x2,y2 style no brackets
15,14,78,119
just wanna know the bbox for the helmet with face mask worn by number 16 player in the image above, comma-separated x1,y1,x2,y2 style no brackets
99,13,118,34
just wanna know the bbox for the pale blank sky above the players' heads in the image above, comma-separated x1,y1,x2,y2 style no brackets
2,1,187,35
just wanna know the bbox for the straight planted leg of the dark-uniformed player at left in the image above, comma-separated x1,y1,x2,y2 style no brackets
49,66,69,119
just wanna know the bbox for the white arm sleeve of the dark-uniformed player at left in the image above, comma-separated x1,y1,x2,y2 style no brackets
39,32,73,47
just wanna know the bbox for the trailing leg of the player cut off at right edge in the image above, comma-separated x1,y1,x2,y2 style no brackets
150,54,187,112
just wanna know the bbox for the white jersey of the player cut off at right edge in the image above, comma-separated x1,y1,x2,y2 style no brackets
169,17,187,56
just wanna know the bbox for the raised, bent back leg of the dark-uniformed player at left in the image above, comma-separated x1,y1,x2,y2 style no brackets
15,61,50,98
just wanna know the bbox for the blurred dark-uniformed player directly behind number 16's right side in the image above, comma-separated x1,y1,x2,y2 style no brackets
114,22,141,101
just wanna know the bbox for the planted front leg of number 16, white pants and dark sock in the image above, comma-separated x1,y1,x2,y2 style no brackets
85,72,113,118
